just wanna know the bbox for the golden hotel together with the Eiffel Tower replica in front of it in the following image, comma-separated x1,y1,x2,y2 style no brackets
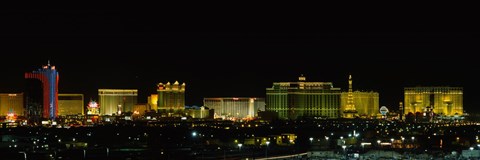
340,75,379,118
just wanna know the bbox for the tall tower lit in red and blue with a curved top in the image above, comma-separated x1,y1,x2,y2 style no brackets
25,61,58,120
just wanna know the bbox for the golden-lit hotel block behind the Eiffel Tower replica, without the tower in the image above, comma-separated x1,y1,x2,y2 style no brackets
341,91,380,118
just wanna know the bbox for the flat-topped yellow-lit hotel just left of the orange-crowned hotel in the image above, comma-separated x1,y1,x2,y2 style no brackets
98,89,138,115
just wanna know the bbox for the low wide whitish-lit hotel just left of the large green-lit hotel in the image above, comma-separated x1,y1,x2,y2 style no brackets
203,97,265,119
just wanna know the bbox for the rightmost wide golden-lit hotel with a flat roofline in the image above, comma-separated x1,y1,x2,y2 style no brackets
403,87,463,116
